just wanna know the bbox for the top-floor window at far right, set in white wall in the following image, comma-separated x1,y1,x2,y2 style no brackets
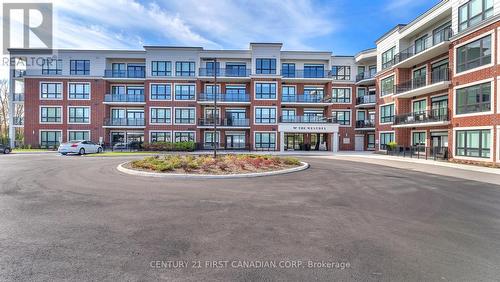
458,0,493,31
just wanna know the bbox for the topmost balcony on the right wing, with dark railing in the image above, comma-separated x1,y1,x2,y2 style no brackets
394,27,453,68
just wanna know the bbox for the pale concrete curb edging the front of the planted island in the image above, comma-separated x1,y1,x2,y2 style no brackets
116,162,309,179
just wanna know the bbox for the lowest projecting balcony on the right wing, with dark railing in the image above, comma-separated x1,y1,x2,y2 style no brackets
393,108,450,127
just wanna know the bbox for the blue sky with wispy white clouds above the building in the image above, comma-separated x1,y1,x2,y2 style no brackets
45,0,439,55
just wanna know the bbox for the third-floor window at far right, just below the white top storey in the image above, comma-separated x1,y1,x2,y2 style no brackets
457,35,491,73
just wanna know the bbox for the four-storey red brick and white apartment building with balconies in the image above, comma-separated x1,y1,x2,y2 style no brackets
10,0,500,163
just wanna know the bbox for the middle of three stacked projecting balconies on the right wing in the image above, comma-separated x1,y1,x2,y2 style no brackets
394,69,450,98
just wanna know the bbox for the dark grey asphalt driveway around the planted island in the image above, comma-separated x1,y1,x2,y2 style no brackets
0,154,500,281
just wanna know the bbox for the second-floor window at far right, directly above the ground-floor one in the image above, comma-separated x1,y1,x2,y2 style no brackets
455,82,491,115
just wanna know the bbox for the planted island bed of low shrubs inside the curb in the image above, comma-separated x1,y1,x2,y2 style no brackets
126,155,303,175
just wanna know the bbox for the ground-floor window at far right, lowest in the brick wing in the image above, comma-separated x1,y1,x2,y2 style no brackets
455,129,491,158
